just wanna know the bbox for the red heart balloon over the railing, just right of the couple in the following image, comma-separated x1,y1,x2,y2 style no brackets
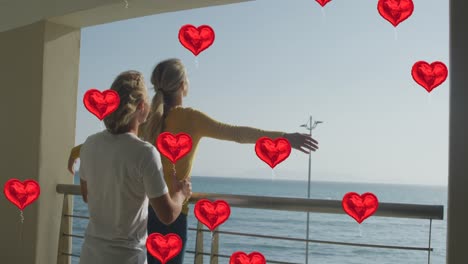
194,199,231,231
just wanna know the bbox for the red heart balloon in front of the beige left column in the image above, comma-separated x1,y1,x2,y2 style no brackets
3,179,41,210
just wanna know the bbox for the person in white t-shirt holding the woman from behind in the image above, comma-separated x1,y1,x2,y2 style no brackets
80,71,191,264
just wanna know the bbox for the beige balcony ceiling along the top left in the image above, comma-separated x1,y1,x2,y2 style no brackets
0,0,253,32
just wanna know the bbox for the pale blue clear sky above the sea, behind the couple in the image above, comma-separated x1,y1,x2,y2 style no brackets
76,0,450,185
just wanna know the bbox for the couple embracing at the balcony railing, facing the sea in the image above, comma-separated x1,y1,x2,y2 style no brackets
68,59,318,264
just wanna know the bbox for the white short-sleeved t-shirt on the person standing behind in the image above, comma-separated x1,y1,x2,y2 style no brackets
79,131,168,264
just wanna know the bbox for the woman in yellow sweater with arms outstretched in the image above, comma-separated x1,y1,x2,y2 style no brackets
68,59,318,264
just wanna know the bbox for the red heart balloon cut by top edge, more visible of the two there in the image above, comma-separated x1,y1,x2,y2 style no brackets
377,0,414,27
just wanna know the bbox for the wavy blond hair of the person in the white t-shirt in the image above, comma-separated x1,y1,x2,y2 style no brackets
104,71,147,134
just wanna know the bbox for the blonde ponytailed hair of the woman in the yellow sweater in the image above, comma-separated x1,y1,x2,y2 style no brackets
140,59,188,144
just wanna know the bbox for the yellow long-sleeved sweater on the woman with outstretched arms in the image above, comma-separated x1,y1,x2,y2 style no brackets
70,107,284,214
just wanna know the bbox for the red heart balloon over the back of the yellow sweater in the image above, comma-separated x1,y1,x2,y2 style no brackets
156,132,192,163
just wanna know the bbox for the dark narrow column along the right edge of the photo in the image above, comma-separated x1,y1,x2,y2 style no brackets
447,0,468,264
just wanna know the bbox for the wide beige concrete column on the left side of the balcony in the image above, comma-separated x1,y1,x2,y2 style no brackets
0,21,80,264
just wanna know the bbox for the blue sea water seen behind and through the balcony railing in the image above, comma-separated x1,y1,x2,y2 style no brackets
72,176,447,264
